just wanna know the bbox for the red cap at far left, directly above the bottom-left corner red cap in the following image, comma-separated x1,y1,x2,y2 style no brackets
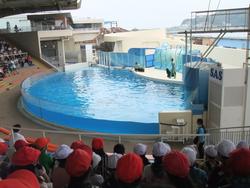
12,146,41,166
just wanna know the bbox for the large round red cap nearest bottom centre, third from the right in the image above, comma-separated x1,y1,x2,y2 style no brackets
116,153,143,183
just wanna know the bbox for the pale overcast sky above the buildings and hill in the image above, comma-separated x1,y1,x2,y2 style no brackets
71,0,250,29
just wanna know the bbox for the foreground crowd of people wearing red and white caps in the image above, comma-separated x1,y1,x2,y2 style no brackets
0,129,250,188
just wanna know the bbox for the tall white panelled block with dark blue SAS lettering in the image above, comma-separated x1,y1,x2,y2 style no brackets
208,67,245,128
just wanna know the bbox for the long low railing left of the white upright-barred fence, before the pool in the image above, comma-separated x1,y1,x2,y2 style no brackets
3,127,210,144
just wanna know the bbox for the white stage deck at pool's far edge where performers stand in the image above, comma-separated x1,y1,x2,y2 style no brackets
133,68,183,84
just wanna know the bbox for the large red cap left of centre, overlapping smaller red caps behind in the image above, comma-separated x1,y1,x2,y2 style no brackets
65,149,92,177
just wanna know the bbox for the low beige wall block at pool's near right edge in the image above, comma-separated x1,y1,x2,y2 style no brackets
159,110,192,134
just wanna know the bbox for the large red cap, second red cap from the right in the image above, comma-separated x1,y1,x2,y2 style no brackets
163,150,189,178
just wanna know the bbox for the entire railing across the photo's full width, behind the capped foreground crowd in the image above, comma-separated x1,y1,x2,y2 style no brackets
4,127,250,145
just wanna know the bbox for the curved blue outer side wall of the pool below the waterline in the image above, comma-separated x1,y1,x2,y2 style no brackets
22,97,159,134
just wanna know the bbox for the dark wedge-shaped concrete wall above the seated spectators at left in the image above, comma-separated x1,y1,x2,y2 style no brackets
2,32,41,58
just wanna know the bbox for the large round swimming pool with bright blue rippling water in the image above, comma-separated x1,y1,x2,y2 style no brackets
22,67,189,134
